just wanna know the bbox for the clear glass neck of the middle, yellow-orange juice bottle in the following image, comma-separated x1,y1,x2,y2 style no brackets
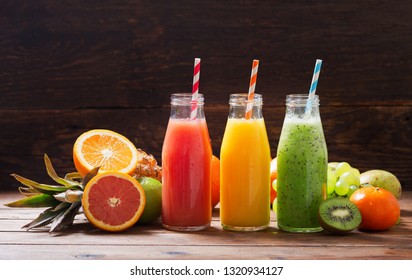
229,93,263,119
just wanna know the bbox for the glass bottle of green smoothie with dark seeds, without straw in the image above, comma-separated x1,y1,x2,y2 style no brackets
277,94,328,232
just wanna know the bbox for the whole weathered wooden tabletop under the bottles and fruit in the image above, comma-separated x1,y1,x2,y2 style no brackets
0,192,412,260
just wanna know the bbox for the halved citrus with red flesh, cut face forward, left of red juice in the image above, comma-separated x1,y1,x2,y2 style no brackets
82,172,146,231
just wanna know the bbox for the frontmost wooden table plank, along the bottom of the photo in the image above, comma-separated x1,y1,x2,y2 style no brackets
0,244,412,260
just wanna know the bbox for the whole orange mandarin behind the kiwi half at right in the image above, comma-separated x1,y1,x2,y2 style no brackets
350,186,401,231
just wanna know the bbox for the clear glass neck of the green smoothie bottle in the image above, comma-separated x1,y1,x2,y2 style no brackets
286,94,320,118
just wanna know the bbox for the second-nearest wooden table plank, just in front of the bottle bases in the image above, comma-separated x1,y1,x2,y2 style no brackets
0,223,412,249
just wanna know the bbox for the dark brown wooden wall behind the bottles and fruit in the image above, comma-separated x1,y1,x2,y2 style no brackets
0,0,412,190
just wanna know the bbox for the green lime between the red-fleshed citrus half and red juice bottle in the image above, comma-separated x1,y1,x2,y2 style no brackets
137,177,162,224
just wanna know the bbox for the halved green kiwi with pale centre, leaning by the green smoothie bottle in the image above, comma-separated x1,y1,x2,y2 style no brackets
319,197,362,234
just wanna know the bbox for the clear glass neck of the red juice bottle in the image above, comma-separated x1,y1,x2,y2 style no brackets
170,93,205,119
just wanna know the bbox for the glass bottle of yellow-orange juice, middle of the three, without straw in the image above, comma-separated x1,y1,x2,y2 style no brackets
220,94,271,231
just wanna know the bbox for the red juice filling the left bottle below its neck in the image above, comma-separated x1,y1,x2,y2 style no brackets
162,118,212,231
